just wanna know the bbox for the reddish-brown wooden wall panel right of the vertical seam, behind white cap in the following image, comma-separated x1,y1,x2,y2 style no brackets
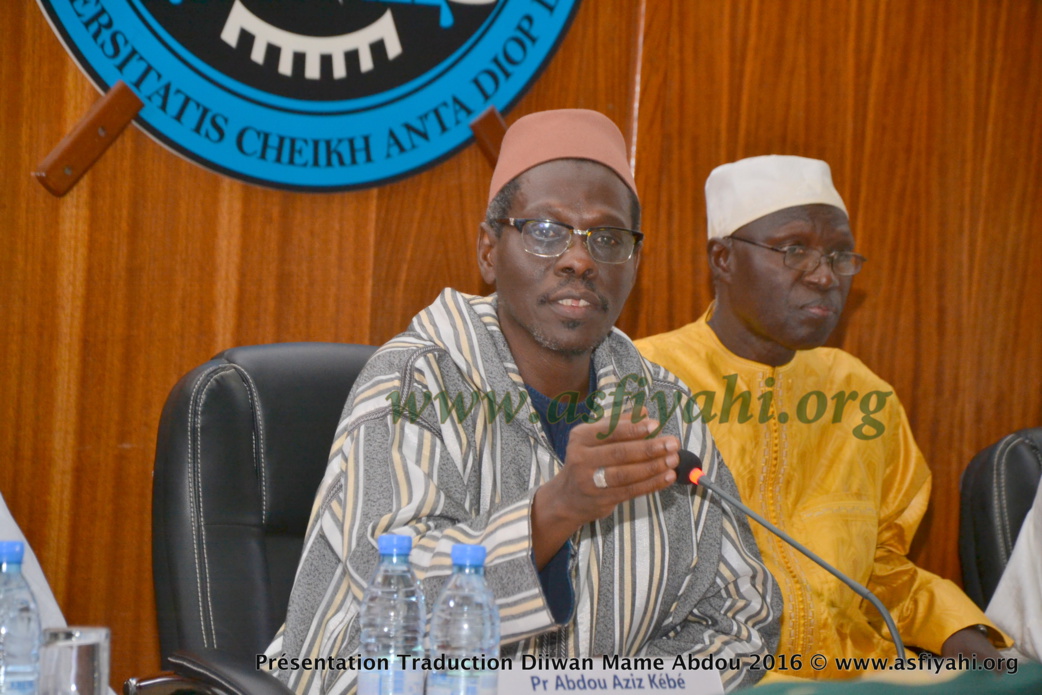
622,0,1042,578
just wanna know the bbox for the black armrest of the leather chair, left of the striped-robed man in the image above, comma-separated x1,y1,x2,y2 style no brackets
123,649,294,695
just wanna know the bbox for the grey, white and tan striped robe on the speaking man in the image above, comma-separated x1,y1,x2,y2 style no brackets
267,290,782,694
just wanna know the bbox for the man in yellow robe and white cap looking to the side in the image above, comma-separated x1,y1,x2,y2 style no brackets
637,155,1008,678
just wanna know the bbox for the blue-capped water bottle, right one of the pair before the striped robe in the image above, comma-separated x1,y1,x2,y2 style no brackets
427,544,499,695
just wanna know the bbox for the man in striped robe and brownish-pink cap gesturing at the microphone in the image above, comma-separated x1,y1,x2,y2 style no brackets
268,109,782,693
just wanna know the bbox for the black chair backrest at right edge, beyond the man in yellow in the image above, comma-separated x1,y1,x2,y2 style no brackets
959,427,1042,609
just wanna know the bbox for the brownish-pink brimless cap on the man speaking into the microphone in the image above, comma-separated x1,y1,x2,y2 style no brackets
489,108,637,203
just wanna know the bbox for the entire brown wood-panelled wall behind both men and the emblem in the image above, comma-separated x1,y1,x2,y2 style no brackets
0,0,1042,684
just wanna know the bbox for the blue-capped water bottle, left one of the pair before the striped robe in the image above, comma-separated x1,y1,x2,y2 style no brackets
358,533,427,695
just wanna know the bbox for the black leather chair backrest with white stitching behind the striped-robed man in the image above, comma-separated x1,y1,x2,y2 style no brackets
152,343,376,668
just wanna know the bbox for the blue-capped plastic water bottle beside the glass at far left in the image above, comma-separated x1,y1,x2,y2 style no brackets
0,541,41,695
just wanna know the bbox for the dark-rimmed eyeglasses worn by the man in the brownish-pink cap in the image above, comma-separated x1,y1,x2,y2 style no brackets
493,217,644,264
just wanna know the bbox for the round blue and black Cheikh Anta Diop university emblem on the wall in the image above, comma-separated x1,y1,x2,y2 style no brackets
38,0,580,191
